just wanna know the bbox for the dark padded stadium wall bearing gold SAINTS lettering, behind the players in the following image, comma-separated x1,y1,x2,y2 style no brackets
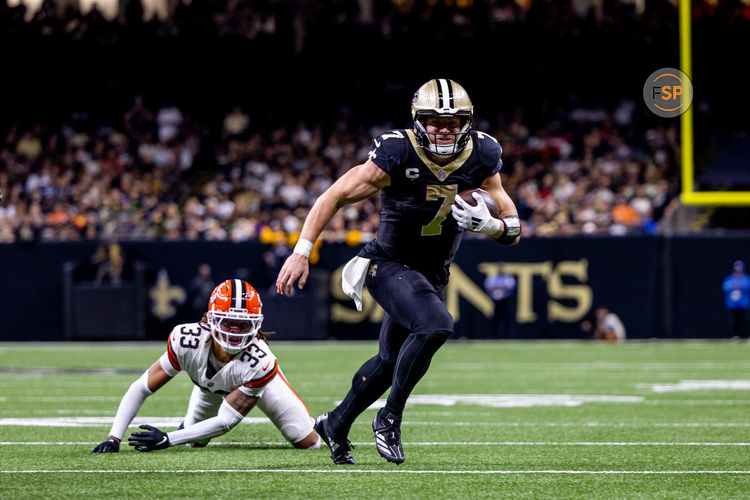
0,237,750,341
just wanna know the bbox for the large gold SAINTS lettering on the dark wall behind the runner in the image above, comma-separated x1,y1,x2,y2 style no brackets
330,259,593,323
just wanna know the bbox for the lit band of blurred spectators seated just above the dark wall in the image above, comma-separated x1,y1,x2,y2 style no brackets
0,97,679,244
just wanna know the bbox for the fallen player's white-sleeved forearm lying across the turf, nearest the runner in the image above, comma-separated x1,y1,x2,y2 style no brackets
128,387,259,451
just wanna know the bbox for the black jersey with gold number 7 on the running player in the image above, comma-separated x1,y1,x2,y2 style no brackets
360,130,502,283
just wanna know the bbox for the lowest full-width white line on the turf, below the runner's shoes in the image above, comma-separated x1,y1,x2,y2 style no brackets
0,468,750,475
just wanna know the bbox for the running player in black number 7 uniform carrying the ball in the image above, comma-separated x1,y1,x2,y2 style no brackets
276,79,521,464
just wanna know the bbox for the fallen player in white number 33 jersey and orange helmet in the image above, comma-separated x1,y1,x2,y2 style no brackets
92,279,320,453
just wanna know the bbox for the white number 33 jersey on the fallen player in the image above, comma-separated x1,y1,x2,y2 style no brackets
159,323,279,397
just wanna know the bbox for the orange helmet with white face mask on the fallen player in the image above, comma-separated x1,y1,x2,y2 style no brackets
206,279,263,354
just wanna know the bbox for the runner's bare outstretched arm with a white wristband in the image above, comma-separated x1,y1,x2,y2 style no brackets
276,160,391,295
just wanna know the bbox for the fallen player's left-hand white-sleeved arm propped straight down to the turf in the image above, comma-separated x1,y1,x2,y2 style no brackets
91,359,176,453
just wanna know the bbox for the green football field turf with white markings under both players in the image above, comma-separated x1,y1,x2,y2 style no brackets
0,341,750,499
